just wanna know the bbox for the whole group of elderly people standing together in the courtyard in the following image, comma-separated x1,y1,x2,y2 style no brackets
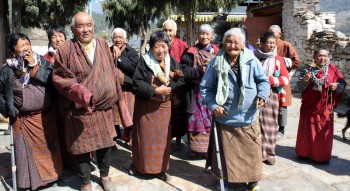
0,12,346,191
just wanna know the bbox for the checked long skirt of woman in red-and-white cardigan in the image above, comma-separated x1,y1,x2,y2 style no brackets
259,89,279,161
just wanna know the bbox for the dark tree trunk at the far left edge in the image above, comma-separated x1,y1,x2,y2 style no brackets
0,0,10,66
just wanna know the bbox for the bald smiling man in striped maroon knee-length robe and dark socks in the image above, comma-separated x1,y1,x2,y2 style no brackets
53,12,132,191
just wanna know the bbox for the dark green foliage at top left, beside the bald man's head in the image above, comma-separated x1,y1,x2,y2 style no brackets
20,0,88,28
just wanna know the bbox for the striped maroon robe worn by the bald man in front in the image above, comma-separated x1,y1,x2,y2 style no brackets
53,38,132,154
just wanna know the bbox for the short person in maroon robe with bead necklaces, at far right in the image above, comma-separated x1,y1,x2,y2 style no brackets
295,48,346,164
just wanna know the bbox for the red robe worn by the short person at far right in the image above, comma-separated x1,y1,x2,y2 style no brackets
295,64,344,162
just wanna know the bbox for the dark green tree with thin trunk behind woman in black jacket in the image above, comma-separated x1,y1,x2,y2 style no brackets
102,0,170,54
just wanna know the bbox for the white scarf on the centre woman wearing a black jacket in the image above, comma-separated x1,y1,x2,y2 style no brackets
143,51,170,81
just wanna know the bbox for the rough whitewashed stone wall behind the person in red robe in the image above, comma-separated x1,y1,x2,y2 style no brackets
282,0,350,94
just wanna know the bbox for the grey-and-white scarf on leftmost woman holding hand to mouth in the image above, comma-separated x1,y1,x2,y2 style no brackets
5,52,41,88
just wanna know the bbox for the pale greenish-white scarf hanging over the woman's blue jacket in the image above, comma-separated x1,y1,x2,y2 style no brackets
213,48,255,107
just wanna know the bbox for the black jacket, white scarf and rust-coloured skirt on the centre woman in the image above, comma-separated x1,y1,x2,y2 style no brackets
132,52,184,174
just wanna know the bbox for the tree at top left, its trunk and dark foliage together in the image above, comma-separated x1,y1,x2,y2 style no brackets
0,0,88,63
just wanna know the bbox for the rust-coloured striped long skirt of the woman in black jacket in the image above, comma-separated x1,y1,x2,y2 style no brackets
132,97,171,174
